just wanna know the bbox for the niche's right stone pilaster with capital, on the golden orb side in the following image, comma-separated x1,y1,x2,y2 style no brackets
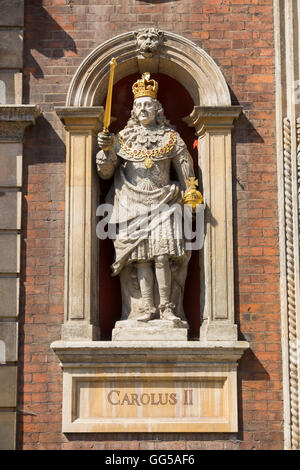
185,106,241,341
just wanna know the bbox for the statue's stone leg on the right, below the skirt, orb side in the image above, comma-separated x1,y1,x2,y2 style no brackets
155,255,180,321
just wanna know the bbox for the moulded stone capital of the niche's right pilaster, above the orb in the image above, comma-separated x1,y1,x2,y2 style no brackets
183,106,243,136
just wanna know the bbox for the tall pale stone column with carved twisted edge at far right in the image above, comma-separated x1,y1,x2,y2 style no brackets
273,0,300,450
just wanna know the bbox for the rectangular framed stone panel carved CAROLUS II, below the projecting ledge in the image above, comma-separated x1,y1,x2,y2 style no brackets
68,373,232,432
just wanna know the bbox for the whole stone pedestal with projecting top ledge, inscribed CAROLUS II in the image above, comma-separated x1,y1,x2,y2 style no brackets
51,341,249,433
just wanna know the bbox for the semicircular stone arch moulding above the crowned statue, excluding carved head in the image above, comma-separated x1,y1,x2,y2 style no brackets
66,32,231,106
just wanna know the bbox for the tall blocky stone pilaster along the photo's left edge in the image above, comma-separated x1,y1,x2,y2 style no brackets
0,0,26,449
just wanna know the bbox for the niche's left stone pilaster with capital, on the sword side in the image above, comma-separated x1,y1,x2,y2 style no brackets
56,107,103,341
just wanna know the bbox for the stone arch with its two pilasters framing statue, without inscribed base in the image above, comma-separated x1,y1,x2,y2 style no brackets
56,32,241,341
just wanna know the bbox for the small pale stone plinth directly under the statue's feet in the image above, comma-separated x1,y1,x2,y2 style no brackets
112,320,188,341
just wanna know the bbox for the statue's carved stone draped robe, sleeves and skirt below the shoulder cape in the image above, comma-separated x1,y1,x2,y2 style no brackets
97,126,194,275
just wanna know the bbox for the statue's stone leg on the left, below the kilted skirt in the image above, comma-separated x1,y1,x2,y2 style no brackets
137,262,156,321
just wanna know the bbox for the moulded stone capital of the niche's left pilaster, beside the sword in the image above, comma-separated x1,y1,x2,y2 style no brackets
54,106,104,132
